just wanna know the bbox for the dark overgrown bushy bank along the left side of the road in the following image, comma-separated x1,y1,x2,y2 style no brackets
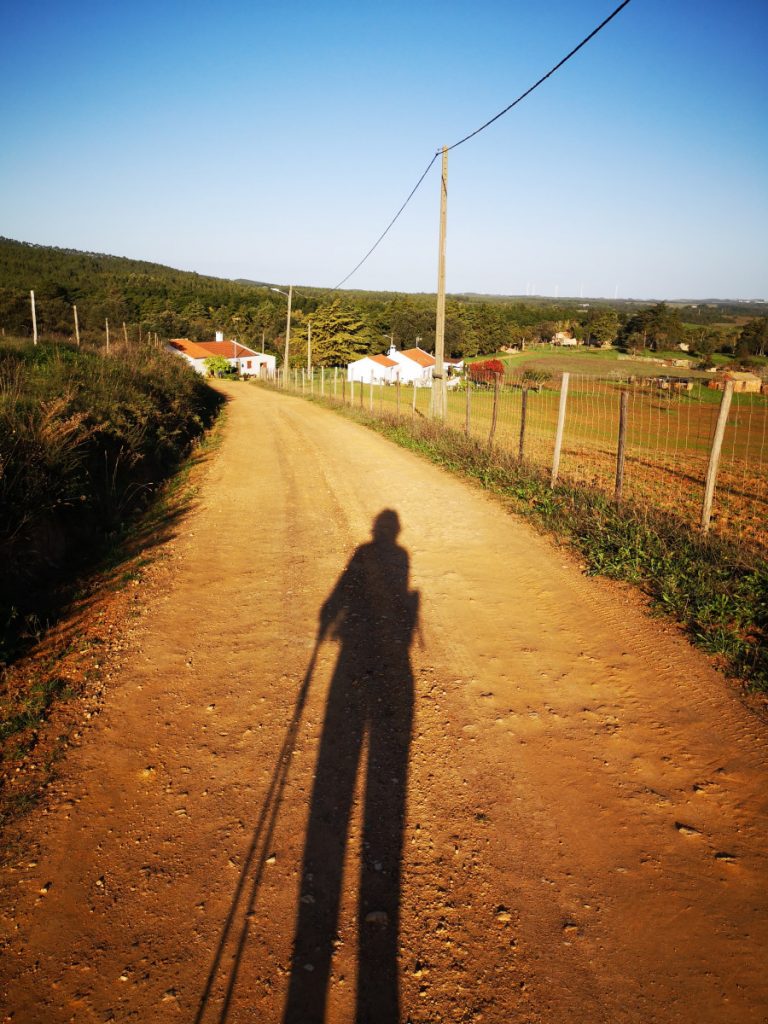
0,340,221,656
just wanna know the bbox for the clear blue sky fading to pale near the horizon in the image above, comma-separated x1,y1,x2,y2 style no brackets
0,0,768,298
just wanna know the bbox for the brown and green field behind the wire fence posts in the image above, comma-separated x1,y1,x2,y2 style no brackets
299,368,768,544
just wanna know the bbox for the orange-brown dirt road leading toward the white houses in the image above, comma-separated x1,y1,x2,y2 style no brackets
1,385,768,1024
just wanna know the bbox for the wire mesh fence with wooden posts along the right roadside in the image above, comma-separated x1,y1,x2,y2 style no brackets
273,368,768,551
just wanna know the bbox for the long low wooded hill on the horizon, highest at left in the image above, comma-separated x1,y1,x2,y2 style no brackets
0,238,766,359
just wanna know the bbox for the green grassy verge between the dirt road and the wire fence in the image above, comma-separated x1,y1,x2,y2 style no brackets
296,398,768,694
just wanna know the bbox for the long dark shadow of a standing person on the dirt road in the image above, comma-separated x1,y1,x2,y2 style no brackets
283,509,419,1024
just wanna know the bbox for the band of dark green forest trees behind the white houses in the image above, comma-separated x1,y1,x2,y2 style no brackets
0,239,768,366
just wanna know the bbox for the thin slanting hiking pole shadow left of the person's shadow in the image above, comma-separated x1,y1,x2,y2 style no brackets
195,634,322,1024
